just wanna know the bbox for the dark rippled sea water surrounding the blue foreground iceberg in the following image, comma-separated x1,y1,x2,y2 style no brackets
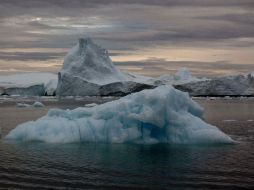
0,99,254,189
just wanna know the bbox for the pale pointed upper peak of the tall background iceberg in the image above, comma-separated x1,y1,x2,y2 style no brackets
60,38,126,84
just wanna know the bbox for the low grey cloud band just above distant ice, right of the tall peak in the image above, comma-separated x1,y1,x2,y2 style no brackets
114,58,253,77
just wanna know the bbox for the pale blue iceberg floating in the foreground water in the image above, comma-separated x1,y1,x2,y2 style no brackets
6,86,233,144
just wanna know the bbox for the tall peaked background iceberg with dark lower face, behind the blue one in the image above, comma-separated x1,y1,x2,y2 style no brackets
56,38,153,96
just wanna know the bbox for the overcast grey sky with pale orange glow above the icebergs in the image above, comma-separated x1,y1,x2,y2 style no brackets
0,0,254,76
